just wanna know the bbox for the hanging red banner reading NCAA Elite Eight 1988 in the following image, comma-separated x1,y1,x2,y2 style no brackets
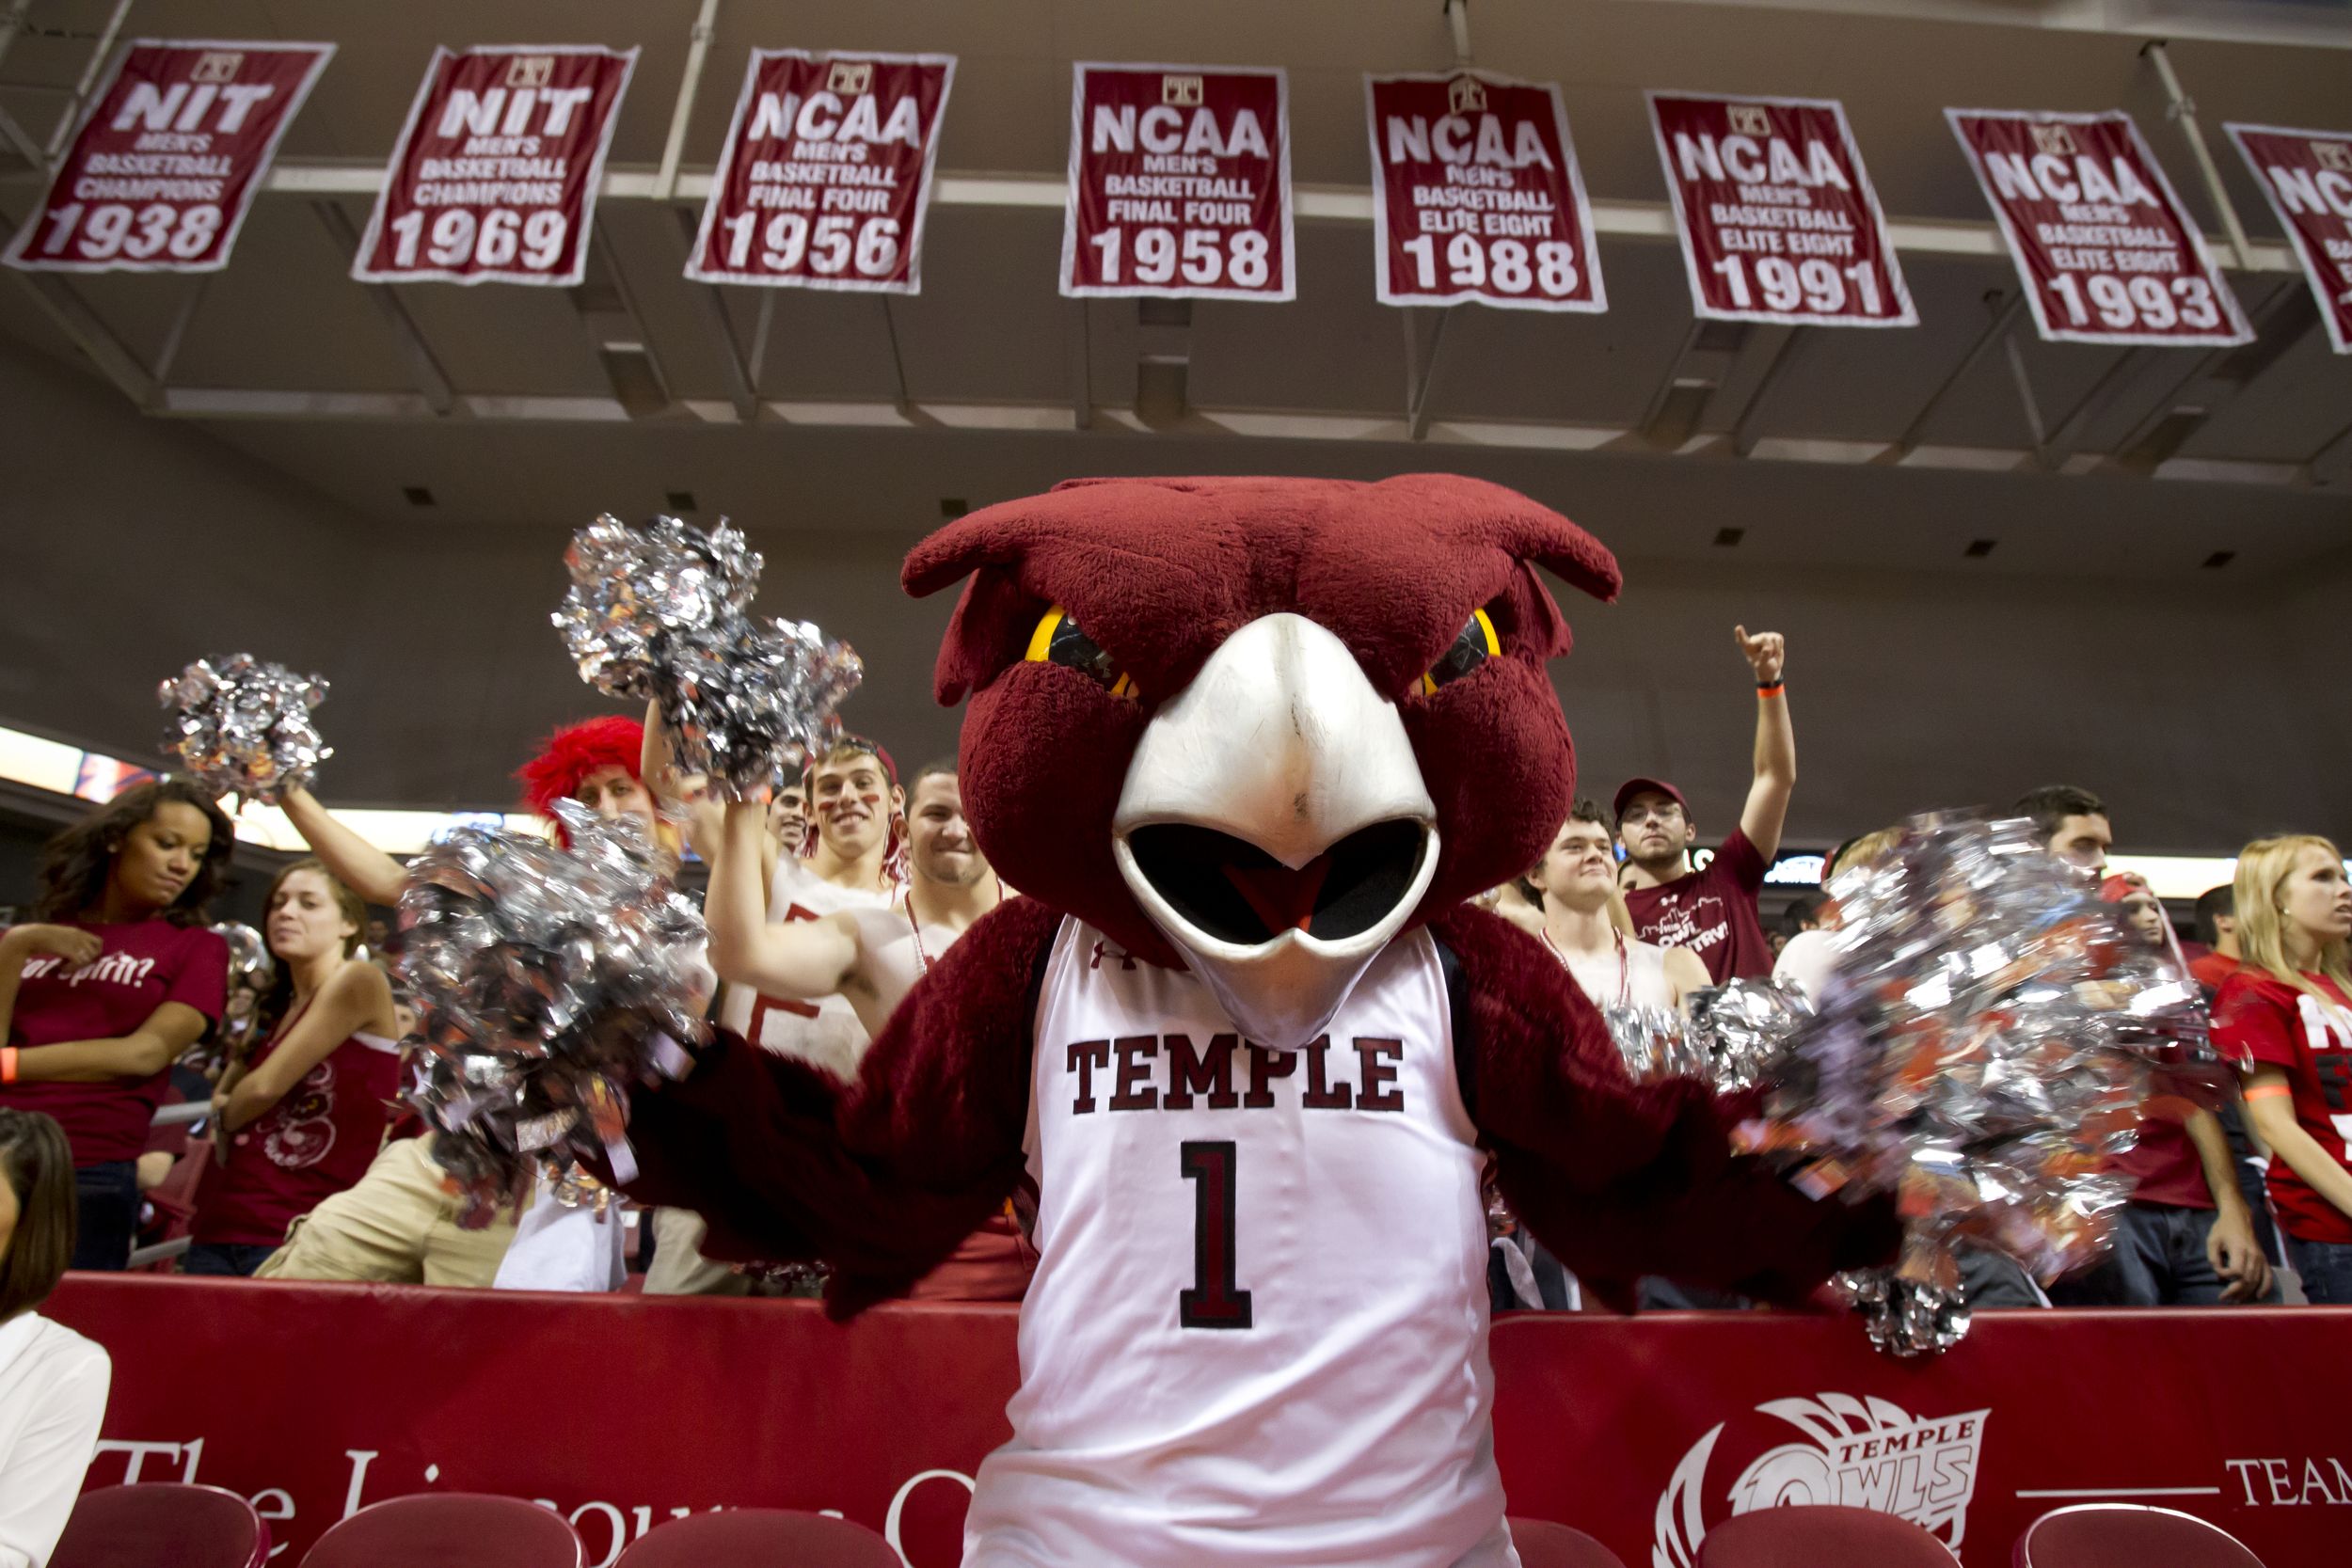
1364,71,1609,310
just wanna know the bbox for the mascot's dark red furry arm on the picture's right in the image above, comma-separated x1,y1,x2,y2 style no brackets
1430,908,1900,1309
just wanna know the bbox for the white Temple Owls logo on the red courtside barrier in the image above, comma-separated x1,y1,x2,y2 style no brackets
1649,1394,1990,1568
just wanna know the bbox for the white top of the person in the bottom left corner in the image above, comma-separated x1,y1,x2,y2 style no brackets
0,1312,113,1568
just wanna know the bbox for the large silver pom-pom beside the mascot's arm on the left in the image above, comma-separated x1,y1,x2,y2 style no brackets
400,801,710,1227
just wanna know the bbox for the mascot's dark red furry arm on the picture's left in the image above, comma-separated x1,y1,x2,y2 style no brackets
624,898,1061,1317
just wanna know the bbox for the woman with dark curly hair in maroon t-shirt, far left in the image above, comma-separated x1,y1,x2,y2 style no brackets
0,778,233,1270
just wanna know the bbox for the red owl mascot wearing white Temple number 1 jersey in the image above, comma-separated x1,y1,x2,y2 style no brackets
628,475,1896,1568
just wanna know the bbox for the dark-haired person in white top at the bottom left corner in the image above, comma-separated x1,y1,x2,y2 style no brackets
0,1107,113,1568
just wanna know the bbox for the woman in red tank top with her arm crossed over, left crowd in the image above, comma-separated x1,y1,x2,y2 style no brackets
182,861,400,1276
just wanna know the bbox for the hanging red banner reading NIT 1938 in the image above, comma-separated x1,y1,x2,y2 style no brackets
8,38,334,273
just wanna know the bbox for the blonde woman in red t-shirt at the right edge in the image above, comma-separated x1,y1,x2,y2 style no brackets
2214,834,2352,1307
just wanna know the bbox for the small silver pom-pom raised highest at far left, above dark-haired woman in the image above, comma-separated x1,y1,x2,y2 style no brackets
155,654,334,806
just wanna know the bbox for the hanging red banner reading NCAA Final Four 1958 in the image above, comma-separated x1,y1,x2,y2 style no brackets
1061,61,1298,301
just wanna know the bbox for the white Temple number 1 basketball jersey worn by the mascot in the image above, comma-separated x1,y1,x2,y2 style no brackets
964,919,1518,1568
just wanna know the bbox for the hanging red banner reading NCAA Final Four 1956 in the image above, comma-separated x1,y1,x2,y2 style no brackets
687,49,955,293
